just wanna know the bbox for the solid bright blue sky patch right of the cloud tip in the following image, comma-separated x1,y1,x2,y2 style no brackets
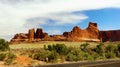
84,8,120,30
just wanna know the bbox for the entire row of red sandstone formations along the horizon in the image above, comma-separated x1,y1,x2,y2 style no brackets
10,22,120,43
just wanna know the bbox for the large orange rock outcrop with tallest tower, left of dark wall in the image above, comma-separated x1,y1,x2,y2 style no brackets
63,22,100,41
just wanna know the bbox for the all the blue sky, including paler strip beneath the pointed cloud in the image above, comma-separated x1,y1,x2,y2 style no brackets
42,8,120,34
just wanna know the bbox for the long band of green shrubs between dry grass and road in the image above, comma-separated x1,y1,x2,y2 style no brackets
28,43,120,62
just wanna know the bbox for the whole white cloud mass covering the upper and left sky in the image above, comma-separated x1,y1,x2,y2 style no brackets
0,0,120,40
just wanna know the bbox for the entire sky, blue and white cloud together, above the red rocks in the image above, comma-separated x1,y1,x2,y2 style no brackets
0,0,120,40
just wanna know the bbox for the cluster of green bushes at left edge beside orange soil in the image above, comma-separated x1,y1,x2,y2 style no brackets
0,39,16,64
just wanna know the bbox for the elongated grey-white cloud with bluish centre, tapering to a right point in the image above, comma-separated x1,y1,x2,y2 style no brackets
26,13,88,27
